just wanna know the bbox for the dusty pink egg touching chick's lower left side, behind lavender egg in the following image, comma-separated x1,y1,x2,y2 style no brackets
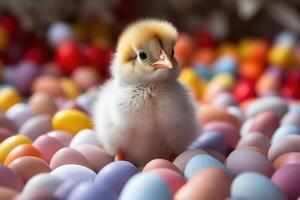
76,144,114,172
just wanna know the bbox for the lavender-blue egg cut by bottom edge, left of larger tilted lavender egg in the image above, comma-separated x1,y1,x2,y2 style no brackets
67,182,118,200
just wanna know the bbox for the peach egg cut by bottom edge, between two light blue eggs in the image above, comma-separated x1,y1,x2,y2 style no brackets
175,167,231,200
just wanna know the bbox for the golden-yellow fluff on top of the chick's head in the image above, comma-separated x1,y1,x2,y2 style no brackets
116,19,178,63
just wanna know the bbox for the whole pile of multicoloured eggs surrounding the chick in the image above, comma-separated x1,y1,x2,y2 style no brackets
0,14,300,200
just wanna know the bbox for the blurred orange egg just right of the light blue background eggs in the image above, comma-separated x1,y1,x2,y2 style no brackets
239,60,264,80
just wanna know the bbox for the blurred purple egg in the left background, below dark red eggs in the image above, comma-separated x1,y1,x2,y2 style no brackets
12,61,40,95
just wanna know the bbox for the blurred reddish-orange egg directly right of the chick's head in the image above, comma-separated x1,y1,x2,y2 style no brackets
174,34,196,67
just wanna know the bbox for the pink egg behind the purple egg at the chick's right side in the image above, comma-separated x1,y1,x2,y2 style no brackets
203,121,240,149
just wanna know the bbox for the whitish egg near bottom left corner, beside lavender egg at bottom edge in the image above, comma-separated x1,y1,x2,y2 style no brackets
22,173,63,194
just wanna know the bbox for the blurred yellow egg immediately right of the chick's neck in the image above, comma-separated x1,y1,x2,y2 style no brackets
179,68,205,99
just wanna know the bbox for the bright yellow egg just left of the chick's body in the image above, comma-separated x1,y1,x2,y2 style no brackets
52,110,93,135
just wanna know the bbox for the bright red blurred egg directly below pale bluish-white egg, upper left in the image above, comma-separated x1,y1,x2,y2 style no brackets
55,42,83,74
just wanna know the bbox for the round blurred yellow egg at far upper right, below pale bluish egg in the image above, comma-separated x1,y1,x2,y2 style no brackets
268,45,293,68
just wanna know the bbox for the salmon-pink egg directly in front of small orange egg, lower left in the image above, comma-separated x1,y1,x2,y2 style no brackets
8,156,51,182
